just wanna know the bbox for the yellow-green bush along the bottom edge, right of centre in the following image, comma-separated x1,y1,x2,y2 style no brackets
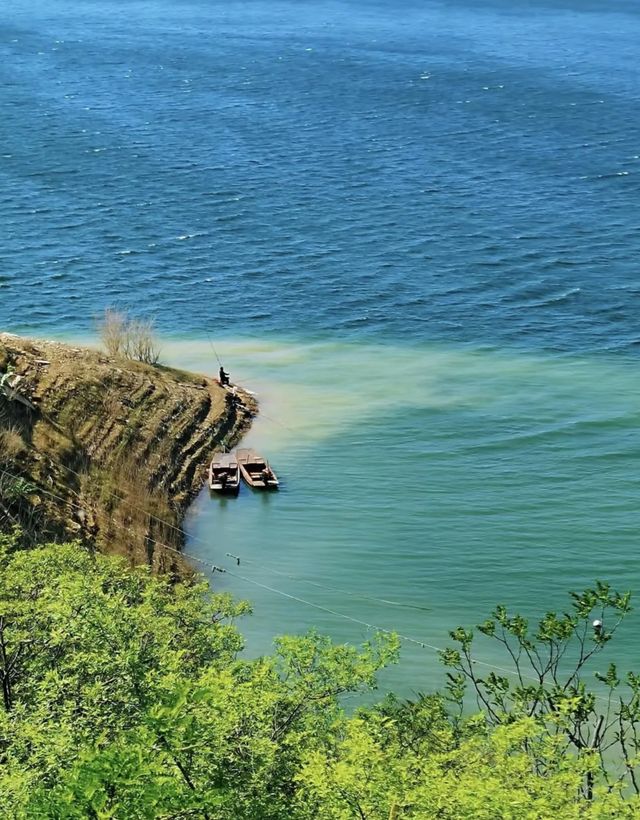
300,703,634,820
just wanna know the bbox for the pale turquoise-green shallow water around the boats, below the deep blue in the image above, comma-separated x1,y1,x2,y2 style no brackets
164,339,640,693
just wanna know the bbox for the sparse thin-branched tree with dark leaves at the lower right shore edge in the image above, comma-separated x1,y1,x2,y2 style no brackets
442,582,640,799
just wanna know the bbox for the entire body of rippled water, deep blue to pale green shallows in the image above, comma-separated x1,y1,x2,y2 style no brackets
0,0,640,691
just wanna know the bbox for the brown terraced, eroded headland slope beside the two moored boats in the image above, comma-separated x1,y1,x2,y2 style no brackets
0,333,256,573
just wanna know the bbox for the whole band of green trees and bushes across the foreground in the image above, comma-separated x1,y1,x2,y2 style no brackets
0,536,640,820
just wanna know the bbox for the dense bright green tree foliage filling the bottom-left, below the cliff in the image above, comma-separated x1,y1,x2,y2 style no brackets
0,544,397,818
